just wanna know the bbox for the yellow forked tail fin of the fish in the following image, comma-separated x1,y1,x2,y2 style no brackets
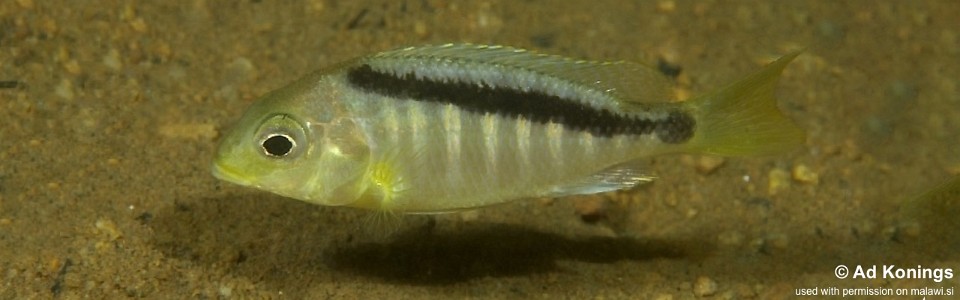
687,51,805,156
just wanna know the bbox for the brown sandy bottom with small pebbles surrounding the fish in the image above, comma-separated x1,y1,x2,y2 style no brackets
0,0,960,299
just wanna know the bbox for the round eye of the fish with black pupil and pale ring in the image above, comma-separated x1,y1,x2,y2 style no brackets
255,114,307,159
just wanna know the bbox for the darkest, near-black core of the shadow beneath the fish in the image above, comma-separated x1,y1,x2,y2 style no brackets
328,222,710,285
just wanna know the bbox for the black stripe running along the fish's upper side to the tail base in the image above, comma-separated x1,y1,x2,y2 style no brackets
347,64,696,144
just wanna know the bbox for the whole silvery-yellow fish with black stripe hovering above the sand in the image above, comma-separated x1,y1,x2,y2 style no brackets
212,44,805,214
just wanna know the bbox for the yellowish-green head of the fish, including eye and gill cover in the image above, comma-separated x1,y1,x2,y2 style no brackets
212,74,370,205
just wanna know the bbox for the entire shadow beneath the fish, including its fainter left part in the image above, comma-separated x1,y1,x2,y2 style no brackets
148,193,714,288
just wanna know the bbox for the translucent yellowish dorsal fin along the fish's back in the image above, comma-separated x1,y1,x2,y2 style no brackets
373,44,675,103
